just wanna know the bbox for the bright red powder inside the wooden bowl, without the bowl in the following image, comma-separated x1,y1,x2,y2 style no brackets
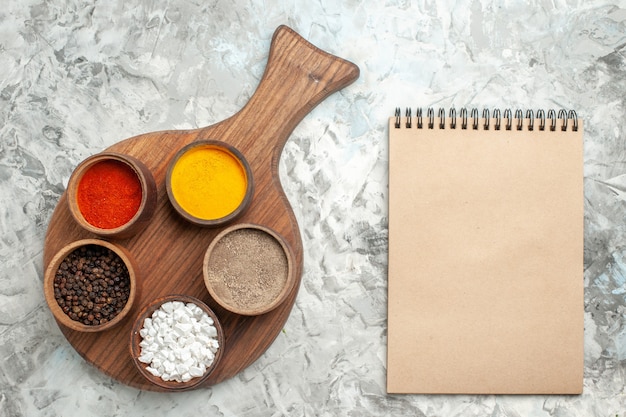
76,160,142,229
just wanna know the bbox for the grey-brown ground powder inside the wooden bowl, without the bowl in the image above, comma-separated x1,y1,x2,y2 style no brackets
207,228,289,310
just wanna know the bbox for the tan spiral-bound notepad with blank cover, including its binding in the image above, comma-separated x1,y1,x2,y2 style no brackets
387,109,584,394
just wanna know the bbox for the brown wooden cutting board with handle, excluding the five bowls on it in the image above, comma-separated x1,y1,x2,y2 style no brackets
44,26,359,391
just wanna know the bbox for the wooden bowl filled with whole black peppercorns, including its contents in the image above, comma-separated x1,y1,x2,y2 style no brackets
44,239,137,332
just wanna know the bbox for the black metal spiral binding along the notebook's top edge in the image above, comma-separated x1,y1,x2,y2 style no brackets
394,107,578,132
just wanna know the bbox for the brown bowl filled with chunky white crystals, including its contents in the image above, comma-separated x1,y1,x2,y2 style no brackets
130,295,224,391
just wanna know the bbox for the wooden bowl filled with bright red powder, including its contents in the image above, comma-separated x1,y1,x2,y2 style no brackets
67,152,157,238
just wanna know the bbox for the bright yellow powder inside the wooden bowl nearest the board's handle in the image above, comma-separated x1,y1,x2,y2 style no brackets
170,145,248,220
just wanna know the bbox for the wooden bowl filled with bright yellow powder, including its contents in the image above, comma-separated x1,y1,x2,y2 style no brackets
165,140,254,227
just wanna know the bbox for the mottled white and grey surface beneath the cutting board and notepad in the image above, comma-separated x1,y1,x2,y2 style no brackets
0,0,626,417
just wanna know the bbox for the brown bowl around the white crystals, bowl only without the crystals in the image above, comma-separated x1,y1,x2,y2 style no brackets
130,294,224,391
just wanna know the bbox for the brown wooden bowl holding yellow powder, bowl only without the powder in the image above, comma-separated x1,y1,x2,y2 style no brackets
165,140,254,227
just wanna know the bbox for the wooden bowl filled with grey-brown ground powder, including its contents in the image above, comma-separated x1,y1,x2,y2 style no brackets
202,223,296,316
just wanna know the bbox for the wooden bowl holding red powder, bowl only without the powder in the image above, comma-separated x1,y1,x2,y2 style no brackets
67,152,157,238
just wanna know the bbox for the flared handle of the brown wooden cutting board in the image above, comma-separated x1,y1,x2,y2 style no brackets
207,25,359,150
